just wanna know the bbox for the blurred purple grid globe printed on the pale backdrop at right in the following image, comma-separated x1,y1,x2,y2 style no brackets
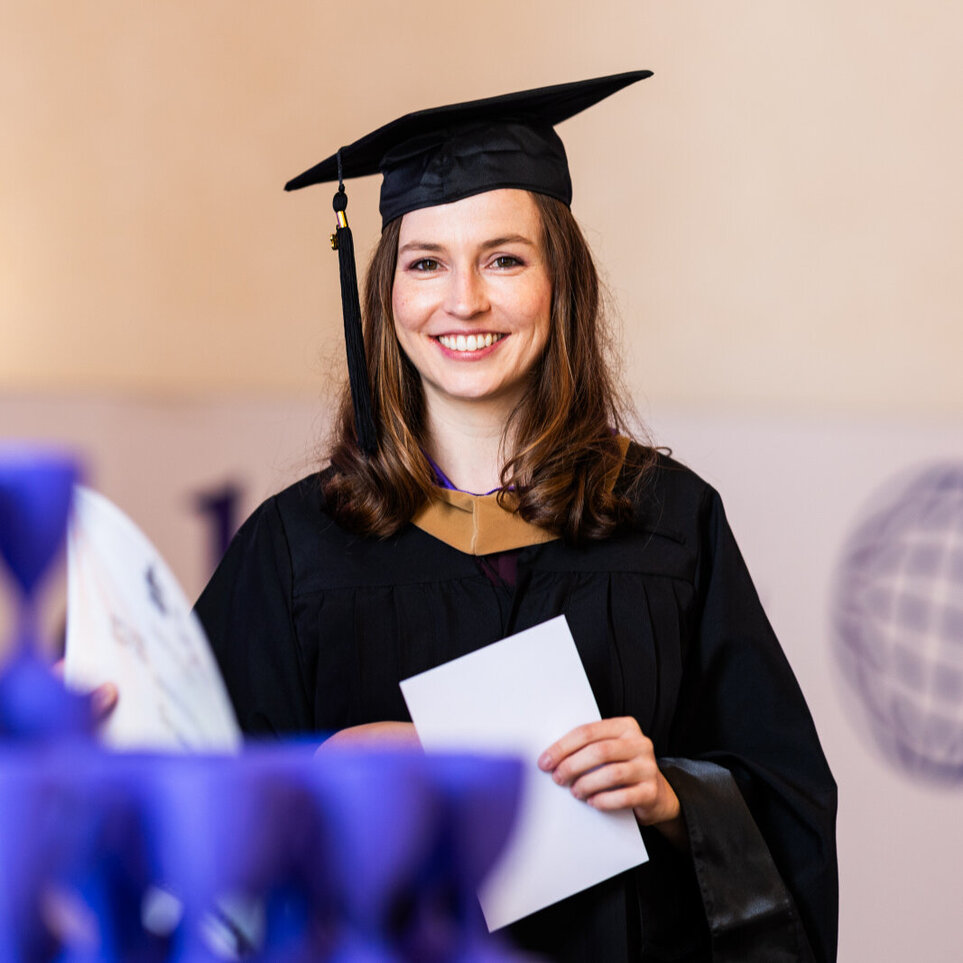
832,464,963,782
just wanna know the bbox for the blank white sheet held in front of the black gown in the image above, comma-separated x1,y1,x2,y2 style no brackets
401,616,648,930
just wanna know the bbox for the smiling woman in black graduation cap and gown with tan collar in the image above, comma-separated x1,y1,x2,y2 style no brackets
198,72,836,961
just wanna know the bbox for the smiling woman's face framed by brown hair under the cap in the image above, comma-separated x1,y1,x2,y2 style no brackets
392,190,552,413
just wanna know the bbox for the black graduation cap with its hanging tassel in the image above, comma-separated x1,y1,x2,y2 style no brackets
285,70,652,455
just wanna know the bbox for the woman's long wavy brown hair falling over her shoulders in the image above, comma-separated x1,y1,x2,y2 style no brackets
324,194,652,544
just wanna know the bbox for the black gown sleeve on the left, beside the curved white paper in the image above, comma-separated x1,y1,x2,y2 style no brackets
195,497,313,736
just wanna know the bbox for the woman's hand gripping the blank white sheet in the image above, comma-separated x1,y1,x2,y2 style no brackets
538,716,685,843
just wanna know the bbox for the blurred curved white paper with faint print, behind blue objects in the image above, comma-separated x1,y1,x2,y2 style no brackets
64,486,242,752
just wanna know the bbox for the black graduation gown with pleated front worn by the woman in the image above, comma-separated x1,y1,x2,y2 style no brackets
197,457,837,963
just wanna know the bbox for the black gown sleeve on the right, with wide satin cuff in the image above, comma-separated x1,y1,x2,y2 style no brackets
660,489,838,963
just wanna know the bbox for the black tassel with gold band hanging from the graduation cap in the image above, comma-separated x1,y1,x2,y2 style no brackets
331,180,378,456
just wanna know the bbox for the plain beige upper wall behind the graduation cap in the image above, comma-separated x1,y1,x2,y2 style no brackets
0,0,963,414
